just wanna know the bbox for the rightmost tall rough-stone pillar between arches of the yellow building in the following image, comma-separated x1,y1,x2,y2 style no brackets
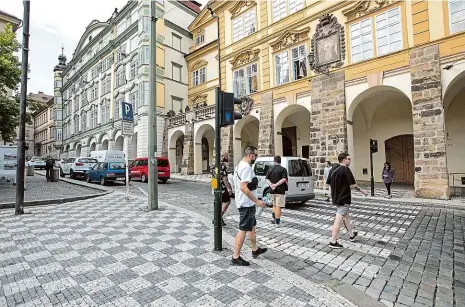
410,45,449,199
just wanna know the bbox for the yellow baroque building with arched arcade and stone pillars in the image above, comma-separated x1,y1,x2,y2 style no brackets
165,0,465,199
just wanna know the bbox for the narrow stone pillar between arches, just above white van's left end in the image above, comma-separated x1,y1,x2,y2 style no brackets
258,92,275,156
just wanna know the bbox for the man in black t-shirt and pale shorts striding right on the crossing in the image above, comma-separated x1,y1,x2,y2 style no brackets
326,153,368,248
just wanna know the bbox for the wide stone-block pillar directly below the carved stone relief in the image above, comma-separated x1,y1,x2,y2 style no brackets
310,71,347,187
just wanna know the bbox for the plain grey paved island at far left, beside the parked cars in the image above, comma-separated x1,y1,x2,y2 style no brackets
0,175,103,203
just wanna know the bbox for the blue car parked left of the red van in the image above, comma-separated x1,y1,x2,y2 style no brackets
86,162,127,185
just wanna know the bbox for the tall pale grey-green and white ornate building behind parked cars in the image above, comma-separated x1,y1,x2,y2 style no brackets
55,0,200,160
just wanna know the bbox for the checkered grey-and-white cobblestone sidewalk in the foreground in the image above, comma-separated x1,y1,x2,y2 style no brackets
0,193,354,307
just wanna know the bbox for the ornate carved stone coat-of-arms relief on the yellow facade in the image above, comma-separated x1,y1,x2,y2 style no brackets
310,14,346,73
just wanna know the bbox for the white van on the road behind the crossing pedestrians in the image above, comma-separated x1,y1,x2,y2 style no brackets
228,156,315,204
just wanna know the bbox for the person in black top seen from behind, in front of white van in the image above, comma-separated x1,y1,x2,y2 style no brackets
265,156,288,226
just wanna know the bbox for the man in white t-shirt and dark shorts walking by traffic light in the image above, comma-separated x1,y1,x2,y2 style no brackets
231,146,267,266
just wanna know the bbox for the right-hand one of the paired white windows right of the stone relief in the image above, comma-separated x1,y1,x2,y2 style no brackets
375,7,403,56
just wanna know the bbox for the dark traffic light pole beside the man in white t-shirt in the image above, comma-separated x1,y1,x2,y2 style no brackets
213,87,223,251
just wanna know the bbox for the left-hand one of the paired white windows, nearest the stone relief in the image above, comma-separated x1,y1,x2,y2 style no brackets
349,17,375,63
